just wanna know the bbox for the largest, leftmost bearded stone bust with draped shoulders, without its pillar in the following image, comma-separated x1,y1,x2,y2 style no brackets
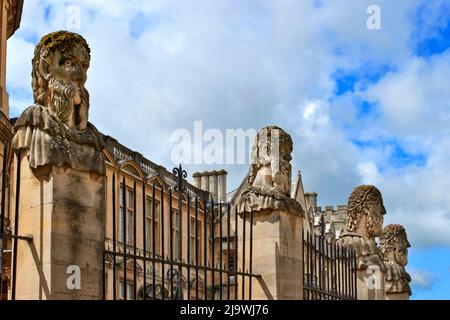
12,31,105,175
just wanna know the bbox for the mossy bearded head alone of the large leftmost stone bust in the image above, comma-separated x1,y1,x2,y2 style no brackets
32,31,90,130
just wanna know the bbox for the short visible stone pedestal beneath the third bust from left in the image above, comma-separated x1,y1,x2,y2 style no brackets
357,266,385,300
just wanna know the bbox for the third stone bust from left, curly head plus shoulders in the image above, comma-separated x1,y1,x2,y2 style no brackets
338,185,386,271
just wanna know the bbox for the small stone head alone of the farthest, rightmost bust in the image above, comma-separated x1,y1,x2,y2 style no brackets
380,224,411,267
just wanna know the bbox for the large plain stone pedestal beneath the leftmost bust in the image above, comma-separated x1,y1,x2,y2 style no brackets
12,152,105,300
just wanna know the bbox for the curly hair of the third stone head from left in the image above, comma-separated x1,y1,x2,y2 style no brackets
347,185,385,232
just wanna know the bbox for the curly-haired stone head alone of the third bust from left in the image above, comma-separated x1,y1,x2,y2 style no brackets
347,185,386,238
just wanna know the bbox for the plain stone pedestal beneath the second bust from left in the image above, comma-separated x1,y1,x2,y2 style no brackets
238,209,303,300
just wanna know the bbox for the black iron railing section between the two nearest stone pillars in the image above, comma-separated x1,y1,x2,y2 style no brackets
104,166,256,300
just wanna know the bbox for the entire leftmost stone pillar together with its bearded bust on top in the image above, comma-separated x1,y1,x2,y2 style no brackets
12,31,105,300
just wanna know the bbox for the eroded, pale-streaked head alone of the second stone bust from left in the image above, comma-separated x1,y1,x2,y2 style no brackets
249,126,293,196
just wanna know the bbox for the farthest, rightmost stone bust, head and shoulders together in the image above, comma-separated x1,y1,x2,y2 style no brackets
380,224,411,296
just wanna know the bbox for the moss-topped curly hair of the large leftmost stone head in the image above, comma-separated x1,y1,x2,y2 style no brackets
31,31,91,105
